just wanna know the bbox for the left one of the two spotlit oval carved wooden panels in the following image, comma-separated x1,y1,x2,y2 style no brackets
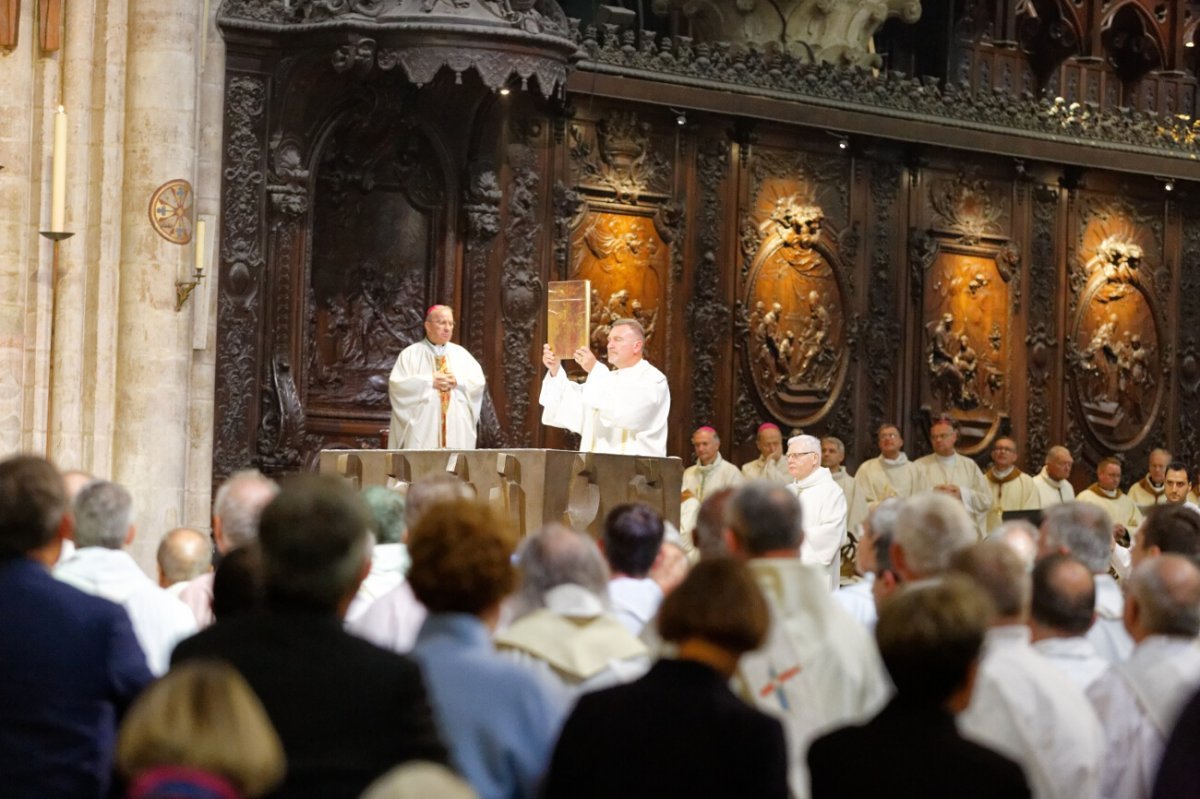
740,149,850,427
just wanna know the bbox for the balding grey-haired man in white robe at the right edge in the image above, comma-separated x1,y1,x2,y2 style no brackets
1088,554,1200,799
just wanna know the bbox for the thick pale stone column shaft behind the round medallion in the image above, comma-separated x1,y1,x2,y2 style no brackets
113,0,203,567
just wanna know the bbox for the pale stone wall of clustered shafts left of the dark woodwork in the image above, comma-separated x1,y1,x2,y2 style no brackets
0,0,224,573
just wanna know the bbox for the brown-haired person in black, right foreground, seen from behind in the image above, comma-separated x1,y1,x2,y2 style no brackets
809,568,1030,799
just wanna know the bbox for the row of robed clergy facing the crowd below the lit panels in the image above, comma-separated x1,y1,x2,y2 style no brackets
680,417,1200,589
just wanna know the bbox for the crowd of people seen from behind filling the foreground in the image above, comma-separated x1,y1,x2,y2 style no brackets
11,448,1200,799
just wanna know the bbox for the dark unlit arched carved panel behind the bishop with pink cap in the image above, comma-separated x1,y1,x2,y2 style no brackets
307,118,445,415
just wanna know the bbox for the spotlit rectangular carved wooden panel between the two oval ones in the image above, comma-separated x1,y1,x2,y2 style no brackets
910,173,1020,453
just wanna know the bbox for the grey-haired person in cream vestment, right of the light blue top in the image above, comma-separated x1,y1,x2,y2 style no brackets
496,524,649,697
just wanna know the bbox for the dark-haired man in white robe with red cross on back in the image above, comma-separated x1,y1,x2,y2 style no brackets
726,482,892,799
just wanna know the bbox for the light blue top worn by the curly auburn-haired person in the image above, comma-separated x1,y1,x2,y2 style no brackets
412,613,566,799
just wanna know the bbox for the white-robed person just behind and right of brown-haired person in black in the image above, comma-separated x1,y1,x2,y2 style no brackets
953,541,1104,799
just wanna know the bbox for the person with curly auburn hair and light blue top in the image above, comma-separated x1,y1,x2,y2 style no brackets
409,499,566,799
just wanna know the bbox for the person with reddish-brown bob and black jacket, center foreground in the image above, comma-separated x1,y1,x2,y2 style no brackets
542,554,788,799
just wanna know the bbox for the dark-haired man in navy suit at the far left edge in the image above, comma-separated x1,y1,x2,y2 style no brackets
0,456,151,799
